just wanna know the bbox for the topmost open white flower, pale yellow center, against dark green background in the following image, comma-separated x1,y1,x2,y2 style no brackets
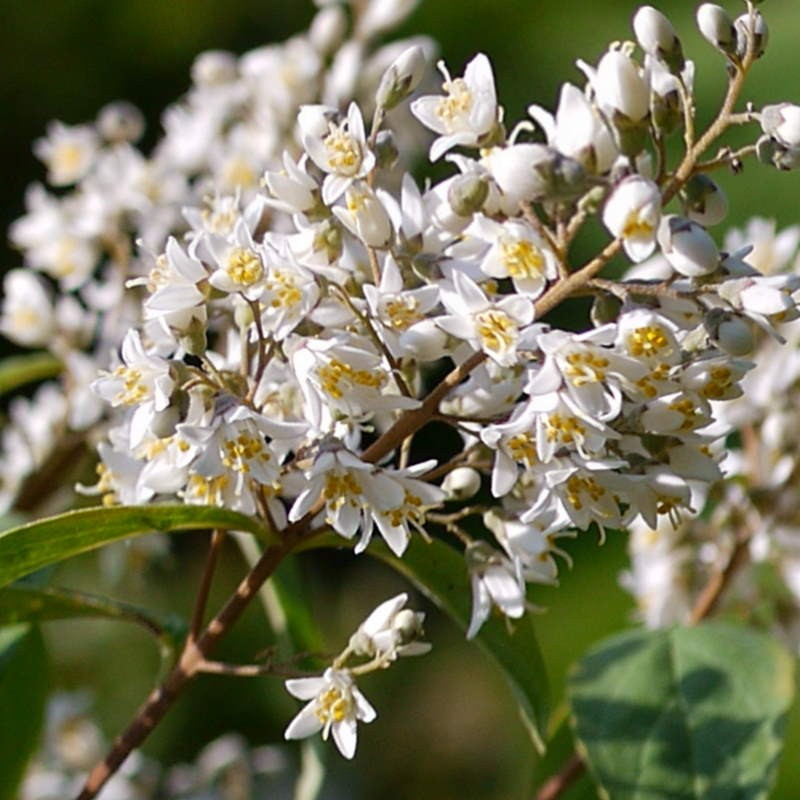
411,53,497,161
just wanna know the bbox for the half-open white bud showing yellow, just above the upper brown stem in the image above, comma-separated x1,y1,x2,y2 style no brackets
603,175,661,263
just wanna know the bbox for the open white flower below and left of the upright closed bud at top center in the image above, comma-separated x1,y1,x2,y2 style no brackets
298,103,375,205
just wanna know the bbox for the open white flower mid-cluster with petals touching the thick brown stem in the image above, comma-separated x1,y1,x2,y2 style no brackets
436,271,533,367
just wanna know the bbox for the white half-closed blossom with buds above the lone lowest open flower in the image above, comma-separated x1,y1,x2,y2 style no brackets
349,593,431,661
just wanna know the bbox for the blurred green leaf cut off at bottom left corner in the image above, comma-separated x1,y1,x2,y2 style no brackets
0,625,48,800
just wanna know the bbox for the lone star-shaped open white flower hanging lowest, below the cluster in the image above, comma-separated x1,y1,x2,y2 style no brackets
284,667,377,758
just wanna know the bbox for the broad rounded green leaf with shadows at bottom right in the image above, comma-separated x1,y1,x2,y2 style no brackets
569,623,795,800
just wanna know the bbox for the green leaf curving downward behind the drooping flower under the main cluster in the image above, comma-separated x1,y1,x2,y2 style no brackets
367,537,549,751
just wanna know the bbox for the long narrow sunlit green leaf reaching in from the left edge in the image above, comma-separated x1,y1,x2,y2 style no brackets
0,505,267,587
